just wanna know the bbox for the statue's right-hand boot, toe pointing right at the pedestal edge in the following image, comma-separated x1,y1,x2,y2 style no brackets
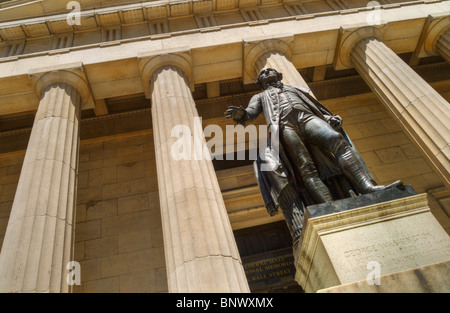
336,146,403,194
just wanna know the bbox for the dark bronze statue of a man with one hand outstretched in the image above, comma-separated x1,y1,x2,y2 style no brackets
225,68,402,246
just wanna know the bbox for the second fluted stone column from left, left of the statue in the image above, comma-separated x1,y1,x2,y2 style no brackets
143,54,249,292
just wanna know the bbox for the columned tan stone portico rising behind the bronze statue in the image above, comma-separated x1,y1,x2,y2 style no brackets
0,1,450,292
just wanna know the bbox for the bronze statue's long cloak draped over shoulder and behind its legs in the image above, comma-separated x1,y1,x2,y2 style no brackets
253,87,373,216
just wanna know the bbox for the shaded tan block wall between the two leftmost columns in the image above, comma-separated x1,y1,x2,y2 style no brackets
74,134,167,292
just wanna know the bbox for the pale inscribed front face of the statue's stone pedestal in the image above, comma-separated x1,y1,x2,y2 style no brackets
328,217,450,282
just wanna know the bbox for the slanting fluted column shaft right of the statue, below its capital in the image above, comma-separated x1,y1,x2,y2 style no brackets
349,37,450,187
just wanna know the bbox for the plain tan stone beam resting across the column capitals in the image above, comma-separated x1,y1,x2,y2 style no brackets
0,1,450,114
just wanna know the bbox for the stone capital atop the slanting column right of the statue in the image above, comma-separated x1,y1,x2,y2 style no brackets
333,24,387,70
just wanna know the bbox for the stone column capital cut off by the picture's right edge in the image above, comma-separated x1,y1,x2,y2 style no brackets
414,13,450,58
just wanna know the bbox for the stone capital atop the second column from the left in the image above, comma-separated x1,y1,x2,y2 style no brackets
137,48,194,99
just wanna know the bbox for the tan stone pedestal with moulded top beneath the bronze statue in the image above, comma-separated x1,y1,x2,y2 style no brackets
294,186,450,292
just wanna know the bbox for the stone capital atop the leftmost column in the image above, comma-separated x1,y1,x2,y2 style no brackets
28,62,95,110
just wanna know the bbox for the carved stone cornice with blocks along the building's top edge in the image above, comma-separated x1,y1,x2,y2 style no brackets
0,0,436,42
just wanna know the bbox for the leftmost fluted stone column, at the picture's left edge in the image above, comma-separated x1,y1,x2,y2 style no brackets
0,67,89,292
